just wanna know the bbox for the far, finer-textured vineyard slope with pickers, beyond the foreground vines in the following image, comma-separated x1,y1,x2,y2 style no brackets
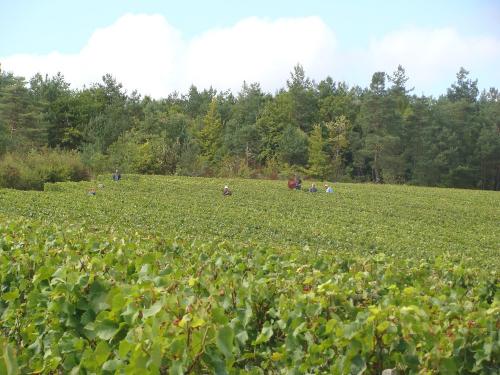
0,176,500,269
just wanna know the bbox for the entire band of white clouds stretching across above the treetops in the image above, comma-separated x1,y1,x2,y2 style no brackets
0,14,500,97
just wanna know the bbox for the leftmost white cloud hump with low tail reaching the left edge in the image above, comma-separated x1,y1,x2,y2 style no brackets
0,14,185,96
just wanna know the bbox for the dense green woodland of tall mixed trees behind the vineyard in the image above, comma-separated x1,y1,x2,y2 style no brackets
0,65,500,190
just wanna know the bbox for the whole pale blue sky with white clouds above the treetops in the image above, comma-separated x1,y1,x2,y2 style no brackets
0,0,500,98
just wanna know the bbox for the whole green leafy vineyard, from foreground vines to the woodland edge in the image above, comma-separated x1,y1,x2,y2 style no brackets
0,175,500,374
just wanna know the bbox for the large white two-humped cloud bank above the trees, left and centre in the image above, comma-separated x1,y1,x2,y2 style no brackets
0,14,335,97
